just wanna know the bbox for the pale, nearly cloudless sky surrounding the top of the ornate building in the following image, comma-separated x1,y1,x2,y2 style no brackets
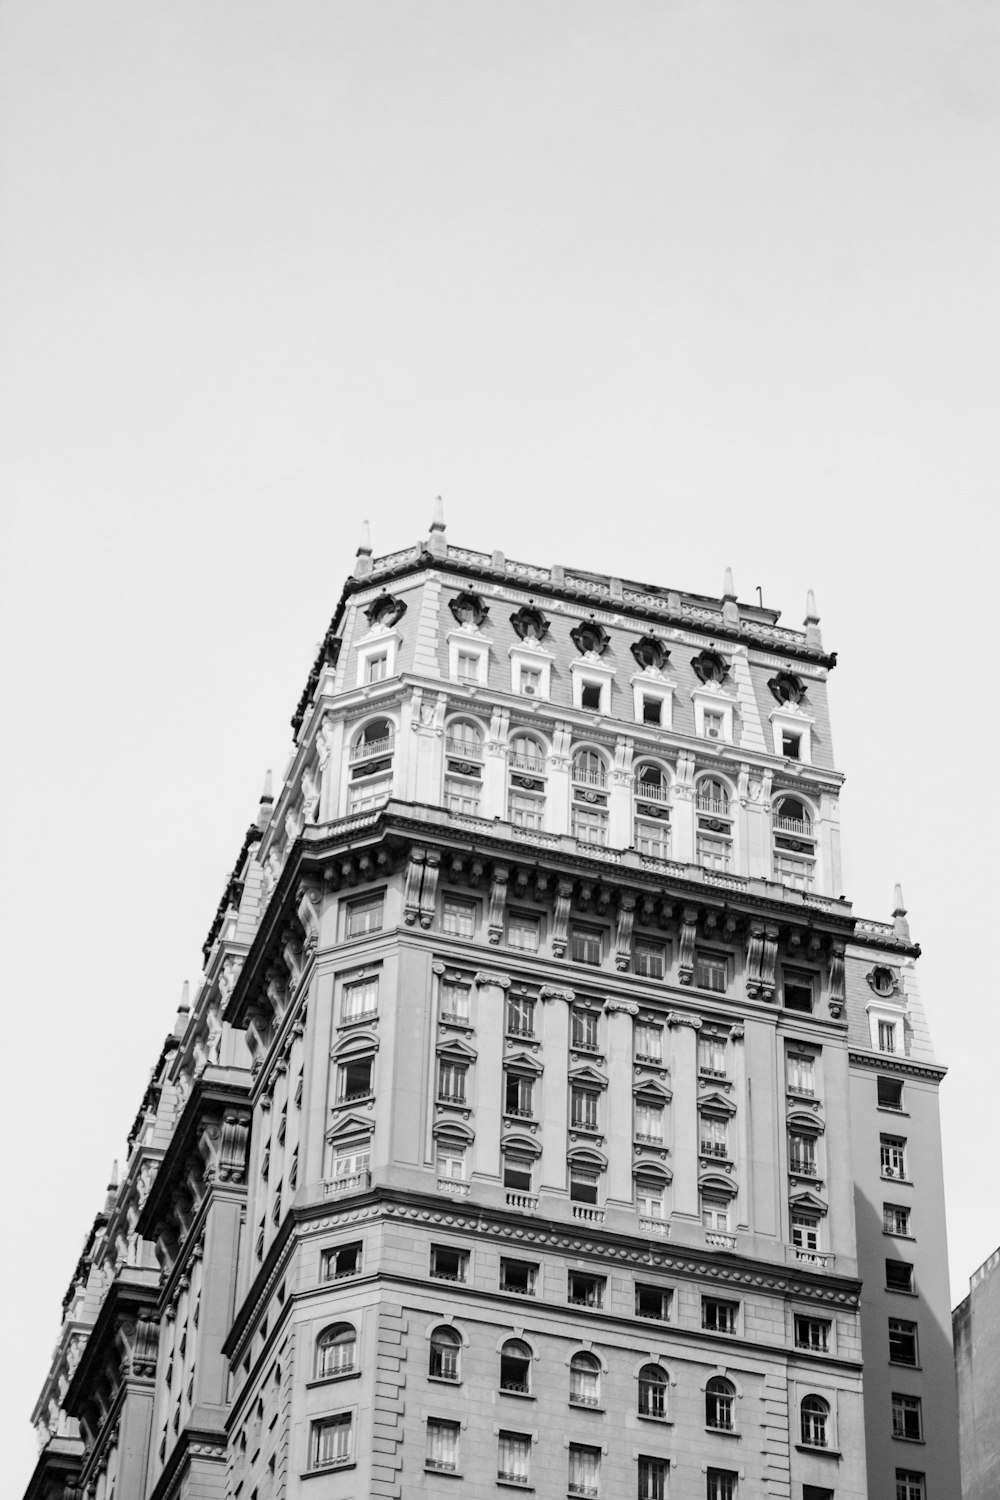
0,0,1000,1494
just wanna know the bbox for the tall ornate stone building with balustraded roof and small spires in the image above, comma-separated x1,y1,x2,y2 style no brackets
27,515,960,1500
